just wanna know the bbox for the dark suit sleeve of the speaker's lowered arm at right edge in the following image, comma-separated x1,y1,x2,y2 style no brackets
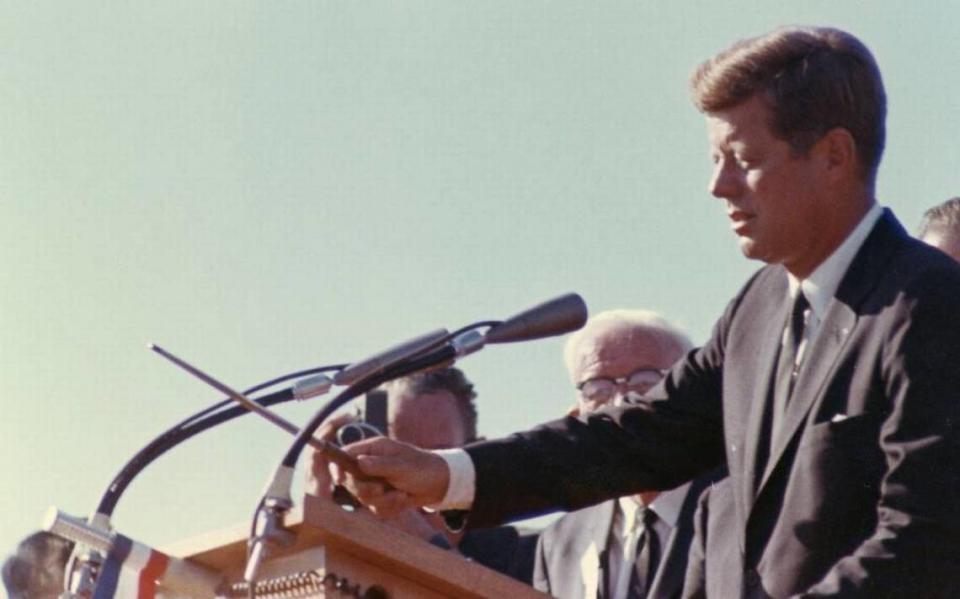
801,272,960,597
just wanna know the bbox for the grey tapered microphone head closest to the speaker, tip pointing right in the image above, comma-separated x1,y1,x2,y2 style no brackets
484,293,587,343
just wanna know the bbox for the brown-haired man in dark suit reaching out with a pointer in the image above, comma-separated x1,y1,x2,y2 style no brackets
328,28,960,598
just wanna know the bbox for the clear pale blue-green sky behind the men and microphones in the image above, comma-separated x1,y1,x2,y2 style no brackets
0,0,960,576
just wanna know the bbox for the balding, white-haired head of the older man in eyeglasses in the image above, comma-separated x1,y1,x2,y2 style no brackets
564,310,693,412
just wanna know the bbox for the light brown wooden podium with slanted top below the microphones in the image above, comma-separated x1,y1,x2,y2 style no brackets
161,495,546,599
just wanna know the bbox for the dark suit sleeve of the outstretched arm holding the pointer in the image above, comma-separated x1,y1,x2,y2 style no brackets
466,278,740,527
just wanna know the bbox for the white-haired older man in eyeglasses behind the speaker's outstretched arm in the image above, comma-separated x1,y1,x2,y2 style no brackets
534,310,709,599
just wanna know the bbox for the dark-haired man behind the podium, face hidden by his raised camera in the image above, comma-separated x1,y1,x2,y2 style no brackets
307,368,536,584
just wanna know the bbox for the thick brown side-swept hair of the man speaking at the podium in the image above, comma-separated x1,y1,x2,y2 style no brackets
690,27,887,187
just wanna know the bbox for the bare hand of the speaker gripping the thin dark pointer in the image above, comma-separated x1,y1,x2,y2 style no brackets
335,437,450,517
